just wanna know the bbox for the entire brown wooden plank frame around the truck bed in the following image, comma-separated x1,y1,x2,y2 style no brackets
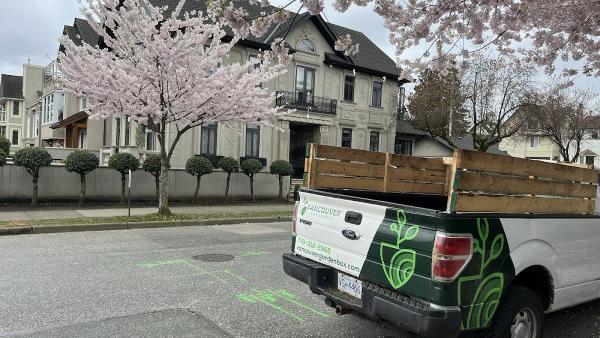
304,144,598,214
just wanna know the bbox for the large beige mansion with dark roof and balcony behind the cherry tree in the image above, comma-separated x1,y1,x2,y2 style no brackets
41,0,410,176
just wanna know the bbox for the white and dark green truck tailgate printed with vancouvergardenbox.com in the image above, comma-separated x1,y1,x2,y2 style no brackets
293,190,435,300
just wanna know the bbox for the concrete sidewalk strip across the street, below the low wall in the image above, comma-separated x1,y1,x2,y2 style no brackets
0,204,292,222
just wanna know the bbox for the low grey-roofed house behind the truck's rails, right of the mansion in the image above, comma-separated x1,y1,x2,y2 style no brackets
394,121,506,158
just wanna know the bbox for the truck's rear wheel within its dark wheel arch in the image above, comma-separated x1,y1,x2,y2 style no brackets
483,285,544,338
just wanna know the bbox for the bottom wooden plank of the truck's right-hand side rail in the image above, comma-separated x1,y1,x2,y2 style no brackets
456,193,595,214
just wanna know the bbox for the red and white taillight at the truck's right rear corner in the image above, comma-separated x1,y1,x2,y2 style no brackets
431,232,473,282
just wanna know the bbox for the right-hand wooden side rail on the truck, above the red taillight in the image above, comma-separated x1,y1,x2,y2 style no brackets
447,150,598,214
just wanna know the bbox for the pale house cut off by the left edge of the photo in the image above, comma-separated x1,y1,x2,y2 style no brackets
0,74,25,152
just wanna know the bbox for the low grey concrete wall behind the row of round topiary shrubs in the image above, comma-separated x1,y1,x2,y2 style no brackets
0,164,290,201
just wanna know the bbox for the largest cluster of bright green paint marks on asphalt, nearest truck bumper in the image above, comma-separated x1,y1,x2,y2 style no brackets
237,289,329,321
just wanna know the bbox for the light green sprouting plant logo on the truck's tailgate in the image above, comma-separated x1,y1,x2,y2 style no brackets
379,210,419,289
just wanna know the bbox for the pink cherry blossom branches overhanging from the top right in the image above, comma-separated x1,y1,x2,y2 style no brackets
216,0,600,76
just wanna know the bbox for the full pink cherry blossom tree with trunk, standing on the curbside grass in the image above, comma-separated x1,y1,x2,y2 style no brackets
58,0,287,213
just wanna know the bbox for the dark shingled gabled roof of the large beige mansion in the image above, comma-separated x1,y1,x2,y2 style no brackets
61,0,401,80
